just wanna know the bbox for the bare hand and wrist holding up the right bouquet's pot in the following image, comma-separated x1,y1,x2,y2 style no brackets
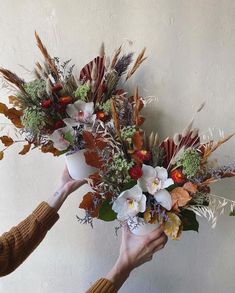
106,225,167,291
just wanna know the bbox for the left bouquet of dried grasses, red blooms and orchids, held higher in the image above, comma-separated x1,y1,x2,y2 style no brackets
0,32,145,176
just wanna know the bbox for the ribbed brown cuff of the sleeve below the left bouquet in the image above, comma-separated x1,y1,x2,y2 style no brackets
33,202,59,230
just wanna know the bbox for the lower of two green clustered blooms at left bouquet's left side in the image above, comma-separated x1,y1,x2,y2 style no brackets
21,106,47,134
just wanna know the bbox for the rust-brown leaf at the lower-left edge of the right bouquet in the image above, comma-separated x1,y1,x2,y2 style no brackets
79,192,101,218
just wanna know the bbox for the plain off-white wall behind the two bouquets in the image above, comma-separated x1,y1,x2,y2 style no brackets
0,0,235,293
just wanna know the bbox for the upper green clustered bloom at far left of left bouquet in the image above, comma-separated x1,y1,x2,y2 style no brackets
24,79,47,102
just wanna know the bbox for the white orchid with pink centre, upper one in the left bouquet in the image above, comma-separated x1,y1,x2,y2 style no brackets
63,100,96,126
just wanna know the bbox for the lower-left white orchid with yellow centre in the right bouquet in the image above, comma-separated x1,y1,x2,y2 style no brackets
112,185,146,221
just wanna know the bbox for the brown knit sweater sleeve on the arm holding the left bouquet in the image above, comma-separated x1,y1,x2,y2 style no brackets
0,202,59,277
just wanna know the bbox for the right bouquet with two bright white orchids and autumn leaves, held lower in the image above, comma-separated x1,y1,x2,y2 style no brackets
78,94,235,239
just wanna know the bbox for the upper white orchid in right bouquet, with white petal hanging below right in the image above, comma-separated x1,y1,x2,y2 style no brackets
138,164,174,210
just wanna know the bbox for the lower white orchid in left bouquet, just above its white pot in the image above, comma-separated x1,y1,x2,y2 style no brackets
50,126,73,151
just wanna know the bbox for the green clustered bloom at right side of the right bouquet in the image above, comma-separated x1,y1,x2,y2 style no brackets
176,148,200,178
